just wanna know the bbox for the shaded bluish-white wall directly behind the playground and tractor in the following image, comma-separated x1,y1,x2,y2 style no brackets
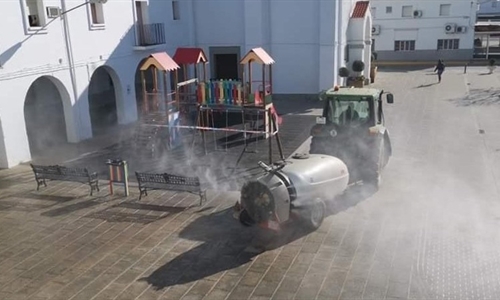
193,0,354,94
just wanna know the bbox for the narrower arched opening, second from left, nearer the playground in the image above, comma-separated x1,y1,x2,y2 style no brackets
89,67,118,136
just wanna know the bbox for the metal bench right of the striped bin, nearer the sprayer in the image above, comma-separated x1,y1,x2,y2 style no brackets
135,172,207,206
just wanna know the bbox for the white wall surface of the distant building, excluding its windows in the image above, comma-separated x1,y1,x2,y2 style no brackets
370,0,476,51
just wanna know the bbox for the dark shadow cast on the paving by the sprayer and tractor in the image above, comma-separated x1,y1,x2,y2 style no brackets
139,186,373,290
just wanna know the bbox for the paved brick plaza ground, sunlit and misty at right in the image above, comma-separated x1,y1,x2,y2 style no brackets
0,67,500,300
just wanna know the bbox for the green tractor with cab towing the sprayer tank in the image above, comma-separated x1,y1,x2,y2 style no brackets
310,87,394,189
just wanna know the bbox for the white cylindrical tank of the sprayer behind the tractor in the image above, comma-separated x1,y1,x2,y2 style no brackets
281,154,349,206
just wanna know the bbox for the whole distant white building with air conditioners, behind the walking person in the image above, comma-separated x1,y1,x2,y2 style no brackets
370,0,477,61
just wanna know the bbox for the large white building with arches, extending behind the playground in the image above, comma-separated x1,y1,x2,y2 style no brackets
0,0,371,168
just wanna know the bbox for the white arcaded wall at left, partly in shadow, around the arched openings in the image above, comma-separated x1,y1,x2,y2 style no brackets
0,0,192,167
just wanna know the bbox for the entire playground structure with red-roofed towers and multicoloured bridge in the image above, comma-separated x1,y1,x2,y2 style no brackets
136,48,284,163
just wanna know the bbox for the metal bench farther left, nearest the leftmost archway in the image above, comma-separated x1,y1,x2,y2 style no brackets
30,164,99,196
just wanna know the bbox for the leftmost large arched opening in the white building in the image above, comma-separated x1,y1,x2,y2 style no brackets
24,76,67,158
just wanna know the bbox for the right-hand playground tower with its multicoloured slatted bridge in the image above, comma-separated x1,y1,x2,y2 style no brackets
193,48,283,162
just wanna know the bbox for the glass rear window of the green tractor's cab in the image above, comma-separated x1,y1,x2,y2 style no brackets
327,96,373,126
